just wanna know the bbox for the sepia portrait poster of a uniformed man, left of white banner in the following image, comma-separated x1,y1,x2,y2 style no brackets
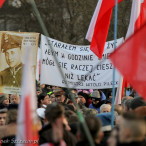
0,31,39,94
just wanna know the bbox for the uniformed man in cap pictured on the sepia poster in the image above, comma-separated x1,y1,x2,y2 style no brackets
0,33,23,87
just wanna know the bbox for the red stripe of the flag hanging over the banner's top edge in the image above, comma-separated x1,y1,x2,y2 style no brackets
90,0,122,59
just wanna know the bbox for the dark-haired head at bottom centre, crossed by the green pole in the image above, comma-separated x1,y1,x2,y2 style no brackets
80,116,103,144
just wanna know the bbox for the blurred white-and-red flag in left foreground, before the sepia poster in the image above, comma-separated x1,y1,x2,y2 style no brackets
16,48,38,146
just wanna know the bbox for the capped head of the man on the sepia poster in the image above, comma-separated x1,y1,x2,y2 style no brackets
2,33,23,67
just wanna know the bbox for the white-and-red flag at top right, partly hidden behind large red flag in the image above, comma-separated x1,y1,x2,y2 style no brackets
115,0,145,104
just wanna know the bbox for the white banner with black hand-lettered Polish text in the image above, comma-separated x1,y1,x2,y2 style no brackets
41,35,123,89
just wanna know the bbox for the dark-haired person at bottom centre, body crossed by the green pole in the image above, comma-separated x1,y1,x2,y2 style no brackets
76,116,103,146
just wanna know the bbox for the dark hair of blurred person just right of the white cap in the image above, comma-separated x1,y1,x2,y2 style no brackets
45,103,64,123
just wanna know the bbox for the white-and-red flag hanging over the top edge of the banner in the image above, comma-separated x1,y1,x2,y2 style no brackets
86,0,122,59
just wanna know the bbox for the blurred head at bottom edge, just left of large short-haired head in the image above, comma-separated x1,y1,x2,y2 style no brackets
107,127,119,146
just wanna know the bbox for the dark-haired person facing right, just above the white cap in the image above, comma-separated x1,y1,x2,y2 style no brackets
38,92,51,108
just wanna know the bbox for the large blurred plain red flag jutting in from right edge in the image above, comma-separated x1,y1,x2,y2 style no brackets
109,24,146,100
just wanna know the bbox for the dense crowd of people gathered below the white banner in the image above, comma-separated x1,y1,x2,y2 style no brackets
0,85,146,146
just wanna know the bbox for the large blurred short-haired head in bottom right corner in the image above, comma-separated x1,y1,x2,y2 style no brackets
119,112,146,143
